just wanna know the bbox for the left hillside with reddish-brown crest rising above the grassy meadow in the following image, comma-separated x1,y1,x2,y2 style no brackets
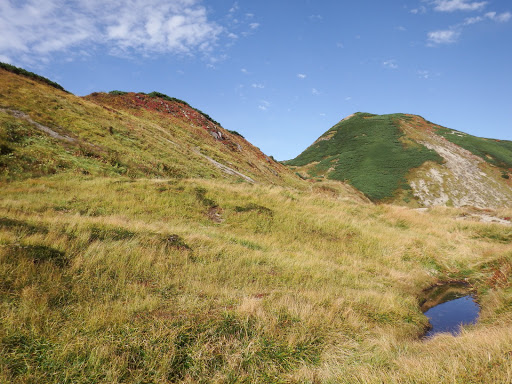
0,69,296,183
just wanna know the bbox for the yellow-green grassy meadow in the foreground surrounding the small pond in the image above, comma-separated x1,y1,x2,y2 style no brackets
0,174,512,383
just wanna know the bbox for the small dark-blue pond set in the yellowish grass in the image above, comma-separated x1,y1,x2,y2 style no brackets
421,283,480,338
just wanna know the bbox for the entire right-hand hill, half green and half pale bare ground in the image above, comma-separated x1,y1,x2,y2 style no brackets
285,113,512,208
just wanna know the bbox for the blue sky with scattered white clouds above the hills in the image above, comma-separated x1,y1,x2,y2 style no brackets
0,0,512,160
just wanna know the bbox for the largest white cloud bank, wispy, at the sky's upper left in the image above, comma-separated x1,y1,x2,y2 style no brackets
0,0,225,58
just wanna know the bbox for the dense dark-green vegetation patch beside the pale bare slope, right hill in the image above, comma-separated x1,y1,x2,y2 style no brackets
286,113,442,200
